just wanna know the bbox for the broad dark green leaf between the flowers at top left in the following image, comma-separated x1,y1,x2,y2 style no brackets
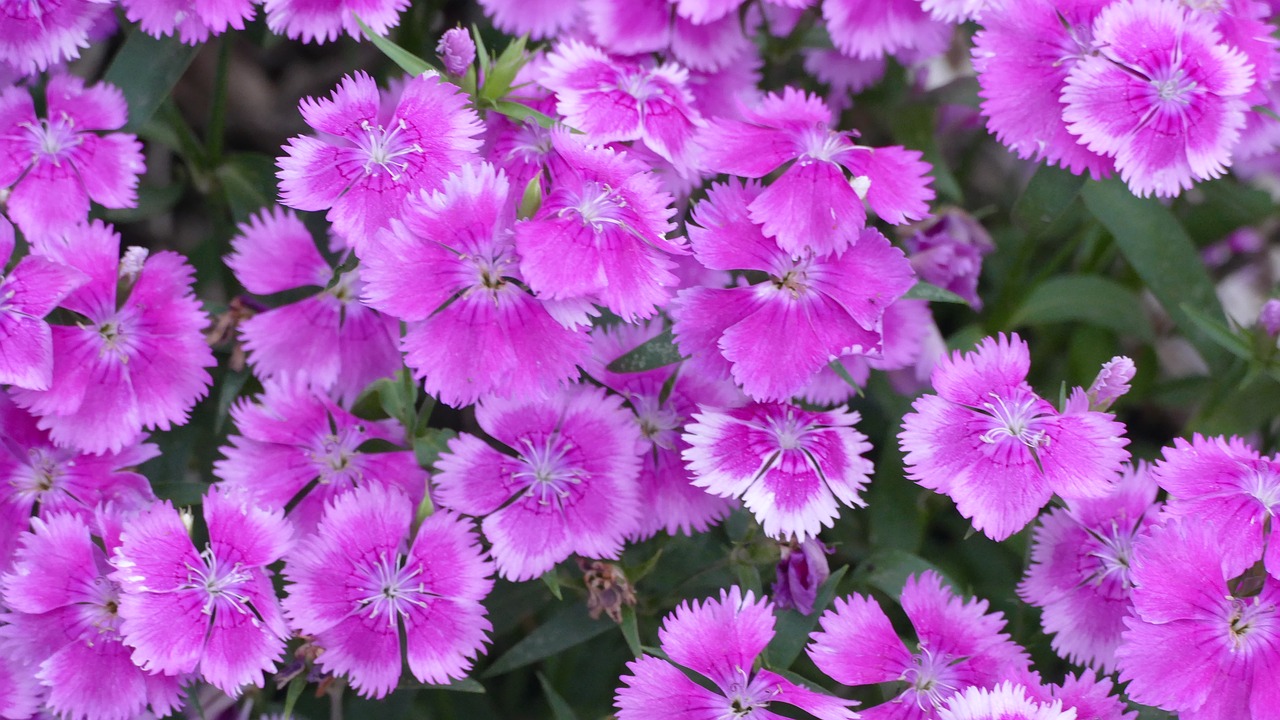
102,27,202,133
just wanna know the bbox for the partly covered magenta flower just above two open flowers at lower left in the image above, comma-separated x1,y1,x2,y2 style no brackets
214,379,426,536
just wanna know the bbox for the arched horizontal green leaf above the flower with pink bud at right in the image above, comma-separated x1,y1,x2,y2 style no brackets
1009,275,1156,342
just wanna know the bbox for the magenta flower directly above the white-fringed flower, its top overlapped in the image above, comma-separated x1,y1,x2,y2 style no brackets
673,182,913,401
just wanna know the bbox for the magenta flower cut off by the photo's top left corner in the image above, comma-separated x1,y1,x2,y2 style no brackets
0,0,110,73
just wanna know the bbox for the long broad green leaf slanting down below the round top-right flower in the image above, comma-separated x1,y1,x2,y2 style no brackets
1082,178,1226,368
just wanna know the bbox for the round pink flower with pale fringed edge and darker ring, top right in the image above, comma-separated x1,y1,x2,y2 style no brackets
1062,0,1253,196
